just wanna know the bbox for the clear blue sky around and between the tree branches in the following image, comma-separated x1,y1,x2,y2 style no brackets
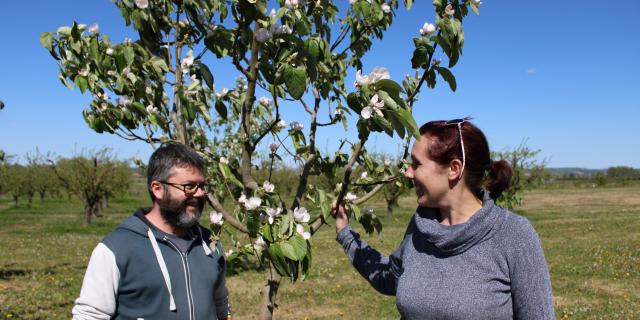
0,0,640,169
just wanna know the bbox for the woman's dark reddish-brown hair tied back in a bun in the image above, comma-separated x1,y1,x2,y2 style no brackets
420,118,513,200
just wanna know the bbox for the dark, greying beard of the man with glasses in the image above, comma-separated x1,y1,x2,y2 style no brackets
159,192,204,229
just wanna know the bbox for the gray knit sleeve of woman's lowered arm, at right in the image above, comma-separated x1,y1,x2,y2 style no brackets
508,217,555,320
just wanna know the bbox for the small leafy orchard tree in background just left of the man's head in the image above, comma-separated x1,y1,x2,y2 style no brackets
51,149,133,225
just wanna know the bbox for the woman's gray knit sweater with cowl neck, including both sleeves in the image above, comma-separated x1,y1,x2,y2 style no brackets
337,199,555,319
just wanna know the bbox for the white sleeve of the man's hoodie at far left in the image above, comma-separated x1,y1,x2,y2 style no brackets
71,243,120,320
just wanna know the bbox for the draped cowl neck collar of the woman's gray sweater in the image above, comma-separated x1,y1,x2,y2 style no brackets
414,192,507,256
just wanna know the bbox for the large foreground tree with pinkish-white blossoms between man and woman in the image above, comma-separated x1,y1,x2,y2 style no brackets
40,0,480,319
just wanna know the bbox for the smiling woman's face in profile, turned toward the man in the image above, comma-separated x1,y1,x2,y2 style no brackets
404,136,450,208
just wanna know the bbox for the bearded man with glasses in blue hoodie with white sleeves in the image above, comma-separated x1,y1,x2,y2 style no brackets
72,144,230,319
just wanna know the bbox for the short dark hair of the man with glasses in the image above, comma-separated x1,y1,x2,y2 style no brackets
147,143,204,201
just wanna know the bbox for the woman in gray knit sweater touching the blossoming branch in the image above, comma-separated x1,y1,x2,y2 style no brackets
334,118,555,319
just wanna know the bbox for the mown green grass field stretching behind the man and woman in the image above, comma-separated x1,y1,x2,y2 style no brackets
0,186,640,320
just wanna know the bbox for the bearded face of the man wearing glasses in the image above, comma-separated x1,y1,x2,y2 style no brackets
156,167,206,229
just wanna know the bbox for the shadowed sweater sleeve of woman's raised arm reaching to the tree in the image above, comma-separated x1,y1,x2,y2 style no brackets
336,226,402,295
